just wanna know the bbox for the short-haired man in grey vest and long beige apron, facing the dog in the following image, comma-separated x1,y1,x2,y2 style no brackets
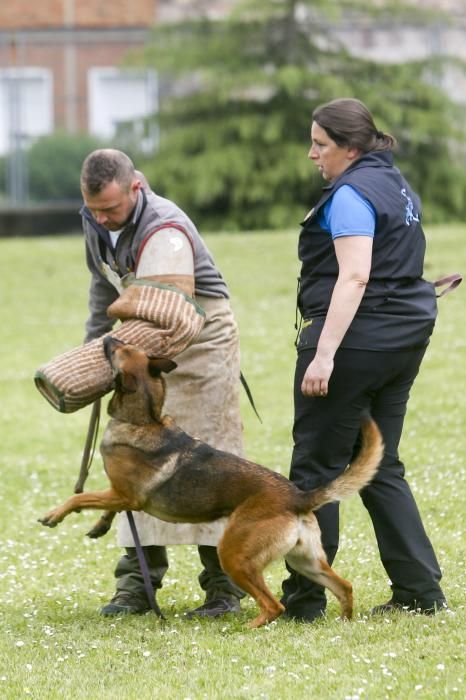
81,149,244,617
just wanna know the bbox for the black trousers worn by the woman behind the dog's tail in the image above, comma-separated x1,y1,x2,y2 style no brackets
282,348,444,618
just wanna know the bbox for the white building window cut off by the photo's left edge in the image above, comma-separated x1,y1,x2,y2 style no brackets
0,68,53,155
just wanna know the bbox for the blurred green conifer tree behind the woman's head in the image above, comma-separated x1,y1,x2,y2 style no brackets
128,0,466,229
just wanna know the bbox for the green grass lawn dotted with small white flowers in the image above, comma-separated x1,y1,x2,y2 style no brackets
0,226,466,700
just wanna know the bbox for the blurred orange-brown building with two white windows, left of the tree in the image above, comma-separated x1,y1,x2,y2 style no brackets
0,0,157,155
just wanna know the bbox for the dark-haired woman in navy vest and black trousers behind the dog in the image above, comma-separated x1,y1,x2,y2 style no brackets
282,99,446,622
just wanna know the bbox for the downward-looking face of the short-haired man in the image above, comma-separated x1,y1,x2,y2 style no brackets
82,180,141,231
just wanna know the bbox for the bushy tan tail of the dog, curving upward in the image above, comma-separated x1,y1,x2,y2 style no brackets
306,416,383,510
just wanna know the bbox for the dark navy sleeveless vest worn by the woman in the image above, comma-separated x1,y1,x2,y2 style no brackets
298,151,437,350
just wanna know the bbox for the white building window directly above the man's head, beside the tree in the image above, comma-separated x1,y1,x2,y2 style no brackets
88,68,158,152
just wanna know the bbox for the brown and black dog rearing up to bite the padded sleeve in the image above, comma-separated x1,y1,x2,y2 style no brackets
40,338,383,627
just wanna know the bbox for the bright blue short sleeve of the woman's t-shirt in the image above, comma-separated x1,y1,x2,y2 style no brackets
318,185,376,238
